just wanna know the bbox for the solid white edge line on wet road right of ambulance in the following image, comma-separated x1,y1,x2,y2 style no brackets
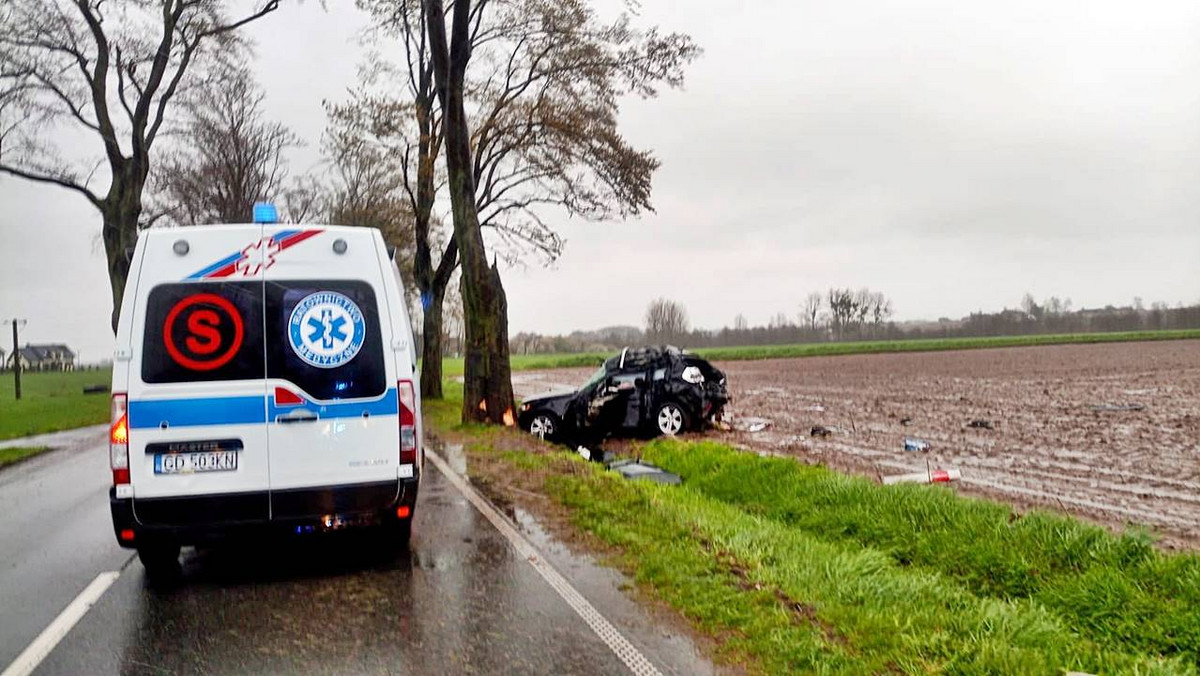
424,450,661,676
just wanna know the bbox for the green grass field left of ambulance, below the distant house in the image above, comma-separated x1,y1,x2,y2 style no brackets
0,369,113,439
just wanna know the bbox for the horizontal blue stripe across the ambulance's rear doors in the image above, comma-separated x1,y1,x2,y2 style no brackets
130,388,400,430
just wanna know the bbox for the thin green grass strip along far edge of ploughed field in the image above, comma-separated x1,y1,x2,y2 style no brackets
443,330,1200,377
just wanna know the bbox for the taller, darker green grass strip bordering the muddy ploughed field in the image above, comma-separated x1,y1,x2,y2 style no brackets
646,441,1200,665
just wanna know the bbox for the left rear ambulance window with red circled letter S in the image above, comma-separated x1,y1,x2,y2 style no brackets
142,282,263,383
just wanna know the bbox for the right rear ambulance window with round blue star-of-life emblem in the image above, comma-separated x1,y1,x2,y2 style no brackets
265,280,388,401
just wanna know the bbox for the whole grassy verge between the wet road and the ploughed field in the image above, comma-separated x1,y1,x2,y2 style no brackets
426,389,1200,674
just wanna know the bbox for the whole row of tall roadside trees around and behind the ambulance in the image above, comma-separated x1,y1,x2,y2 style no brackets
0,0,698,423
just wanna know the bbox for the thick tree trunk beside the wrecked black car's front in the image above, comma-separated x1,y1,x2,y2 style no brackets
425,0,515,425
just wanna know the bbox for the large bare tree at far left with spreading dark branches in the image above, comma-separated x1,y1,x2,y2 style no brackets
0,0,280,330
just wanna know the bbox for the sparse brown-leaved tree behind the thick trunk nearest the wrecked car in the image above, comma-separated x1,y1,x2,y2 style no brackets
342,0,698,397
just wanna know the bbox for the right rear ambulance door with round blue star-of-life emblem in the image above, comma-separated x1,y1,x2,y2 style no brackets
264,226,400,519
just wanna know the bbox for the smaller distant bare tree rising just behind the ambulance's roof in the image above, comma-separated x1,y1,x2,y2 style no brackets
150,67,301,225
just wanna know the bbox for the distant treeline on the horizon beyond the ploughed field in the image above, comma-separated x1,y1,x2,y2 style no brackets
511,289,1200,354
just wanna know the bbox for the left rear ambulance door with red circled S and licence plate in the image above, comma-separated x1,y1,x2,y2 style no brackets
127,226,270,525
